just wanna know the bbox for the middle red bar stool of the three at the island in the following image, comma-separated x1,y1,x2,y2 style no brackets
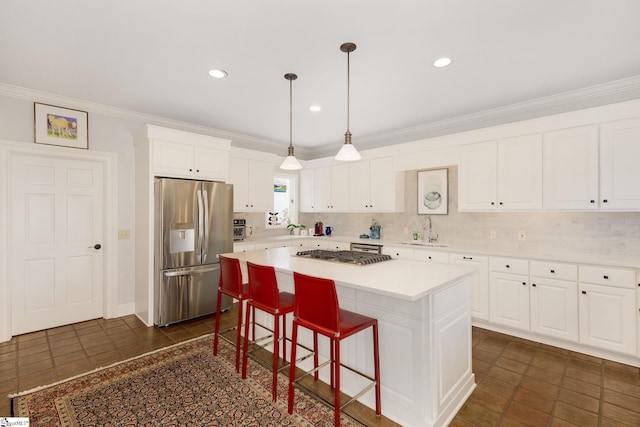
242,262,293,402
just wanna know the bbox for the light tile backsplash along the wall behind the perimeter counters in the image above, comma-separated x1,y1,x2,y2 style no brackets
238,166,640,257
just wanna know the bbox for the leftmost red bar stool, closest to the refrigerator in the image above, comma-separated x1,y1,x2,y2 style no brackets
213,255,249,372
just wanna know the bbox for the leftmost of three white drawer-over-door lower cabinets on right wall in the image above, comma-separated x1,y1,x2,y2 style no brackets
489,257,529,330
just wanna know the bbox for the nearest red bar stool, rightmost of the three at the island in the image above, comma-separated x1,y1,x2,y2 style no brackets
288,272,381,426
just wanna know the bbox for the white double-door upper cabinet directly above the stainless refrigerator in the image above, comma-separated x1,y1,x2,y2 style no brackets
151,138,229,181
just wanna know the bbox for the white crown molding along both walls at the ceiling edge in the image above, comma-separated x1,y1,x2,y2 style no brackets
5,75,640,160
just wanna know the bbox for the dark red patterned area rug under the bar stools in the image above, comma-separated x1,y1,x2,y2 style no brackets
12,335,362,427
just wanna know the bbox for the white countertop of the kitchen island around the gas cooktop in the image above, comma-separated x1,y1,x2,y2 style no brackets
223,247,475,301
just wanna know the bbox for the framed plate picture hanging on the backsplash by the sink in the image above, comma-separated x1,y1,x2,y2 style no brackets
418,169,449,215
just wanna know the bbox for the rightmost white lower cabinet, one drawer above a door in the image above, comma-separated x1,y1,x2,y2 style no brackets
579,266,638,355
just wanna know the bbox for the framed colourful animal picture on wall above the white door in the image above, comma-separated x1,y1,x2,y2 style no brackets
33,102,89,150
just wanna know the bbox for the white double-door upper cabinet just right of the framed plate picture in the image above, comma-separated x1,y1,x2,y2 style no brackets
459,135,542,211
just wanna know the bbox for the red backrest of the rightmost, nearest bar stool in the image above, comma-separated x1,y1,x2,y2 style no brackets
293,272,340,335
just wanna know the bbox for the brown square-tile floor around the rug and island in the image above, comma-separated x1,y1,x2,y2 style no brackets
0,310,640,427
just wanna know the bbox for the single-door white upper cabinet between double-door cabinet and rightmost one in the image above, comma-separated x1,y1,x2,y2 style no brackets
543,126,599,210
